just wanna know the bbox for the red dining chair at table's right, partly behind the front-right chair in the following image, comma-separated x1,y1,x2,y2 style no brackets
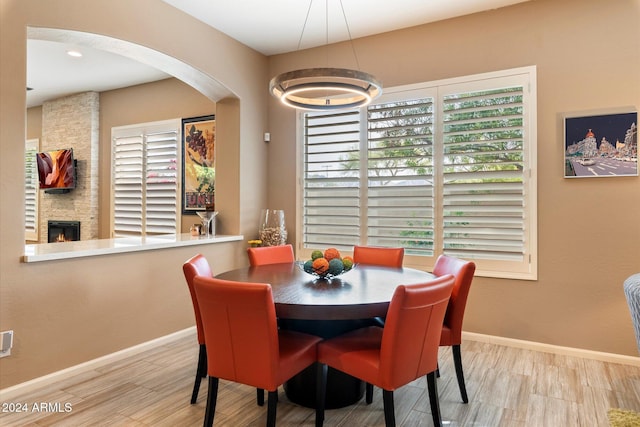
433,255,476,403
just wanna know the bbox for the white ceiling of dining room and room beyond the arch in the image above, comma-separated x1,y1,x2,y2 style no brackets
27,0,529,107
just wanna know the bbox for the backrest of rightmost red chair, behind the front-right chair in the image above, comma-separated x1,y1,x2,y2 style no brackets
433,255,476,344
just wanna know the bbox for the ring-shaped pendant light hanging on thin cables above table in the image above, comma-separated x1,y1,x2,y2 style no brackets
269,0,382,111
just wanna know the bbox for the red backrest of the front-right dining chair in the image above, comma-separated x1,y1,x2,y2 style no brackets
379,275,455,390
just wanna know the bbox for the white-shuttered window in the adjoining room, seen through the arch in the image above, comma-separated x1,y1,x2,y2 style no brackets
111,119,181,237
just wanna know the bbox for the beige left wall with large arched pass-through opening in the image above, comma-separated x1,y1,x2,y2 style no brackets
0,0,268,388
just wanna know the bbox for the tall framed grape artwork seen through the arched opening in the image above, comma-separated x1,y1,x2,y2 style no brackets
182,115,216,214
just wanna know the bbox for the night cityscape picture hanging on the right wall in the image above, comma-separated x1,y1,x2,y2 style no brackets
564,108,638,178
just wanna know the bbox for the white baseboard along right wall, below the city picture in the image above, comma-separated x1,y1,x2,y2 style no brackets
462,331,640,366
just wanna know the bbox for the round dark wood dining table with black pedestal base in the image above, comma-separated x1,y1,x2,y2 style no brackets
216,262,435,409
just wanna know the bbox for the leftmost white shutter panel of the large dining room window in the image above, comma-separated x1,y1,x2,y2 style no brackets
303,110,360,249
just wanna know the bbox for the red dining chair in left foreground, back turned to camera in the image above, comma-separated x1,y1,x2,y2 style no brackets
194,276,321,426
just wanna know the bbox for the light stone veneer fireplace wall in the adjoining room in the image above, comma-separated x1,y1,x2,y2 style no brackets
38,92,100,243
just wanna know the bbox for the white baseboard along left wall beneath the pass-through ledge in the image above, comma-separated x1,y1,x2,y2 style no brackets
0,326,197,402
